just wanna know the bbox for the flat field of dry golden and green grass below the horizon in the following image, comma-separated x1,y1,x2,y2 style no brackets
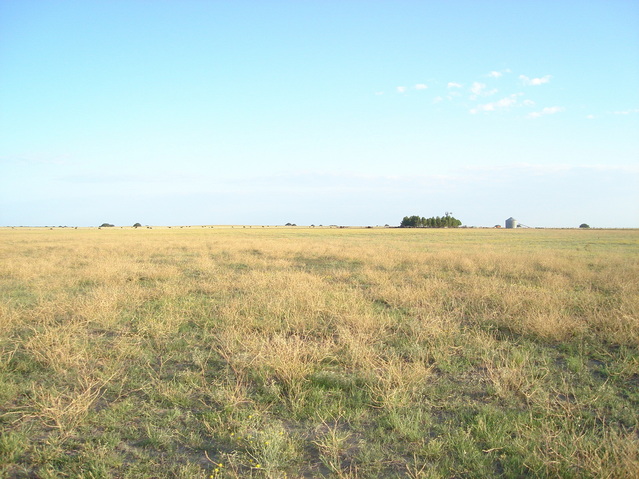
0,227,639,478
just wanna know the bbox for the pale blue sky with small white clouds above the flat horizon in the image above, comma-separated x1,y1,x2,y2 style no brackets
0,0,639,228
